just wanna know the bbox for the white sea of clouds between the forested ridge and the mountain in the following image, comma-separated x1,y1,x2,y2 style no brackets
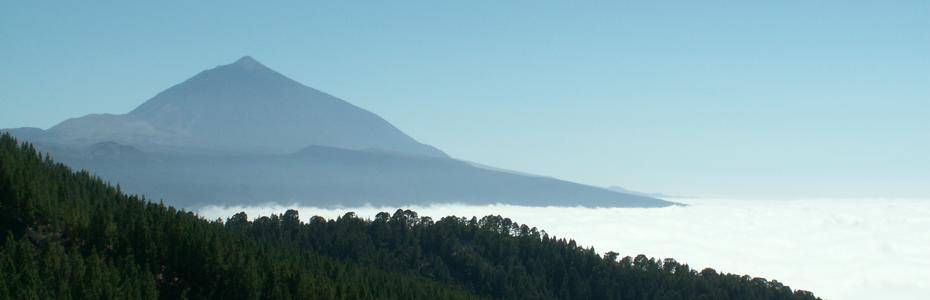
197,199,930,299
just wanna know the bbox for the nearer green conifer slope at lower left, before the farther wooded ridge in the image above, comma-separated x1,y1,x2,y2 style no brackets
0,134,478,299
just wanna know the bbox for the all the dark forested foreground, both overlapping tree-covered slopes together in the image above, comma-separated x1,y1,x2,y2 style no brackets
0,134,817,299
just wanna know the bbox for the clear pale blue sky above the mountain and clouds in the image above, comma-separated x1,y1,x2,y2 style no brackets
0,0,930,198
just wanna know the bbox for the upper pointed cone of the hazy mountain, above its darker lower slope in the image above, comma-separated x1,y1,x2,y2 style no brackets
35,56,446,157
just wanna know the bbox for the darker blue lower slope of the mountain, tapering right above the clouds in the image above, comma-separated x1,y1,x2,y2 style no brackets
47,143,672,207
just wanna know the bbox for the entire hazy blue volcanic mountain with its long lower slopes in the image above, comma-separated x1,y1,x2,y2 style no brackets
6,57,672,207
